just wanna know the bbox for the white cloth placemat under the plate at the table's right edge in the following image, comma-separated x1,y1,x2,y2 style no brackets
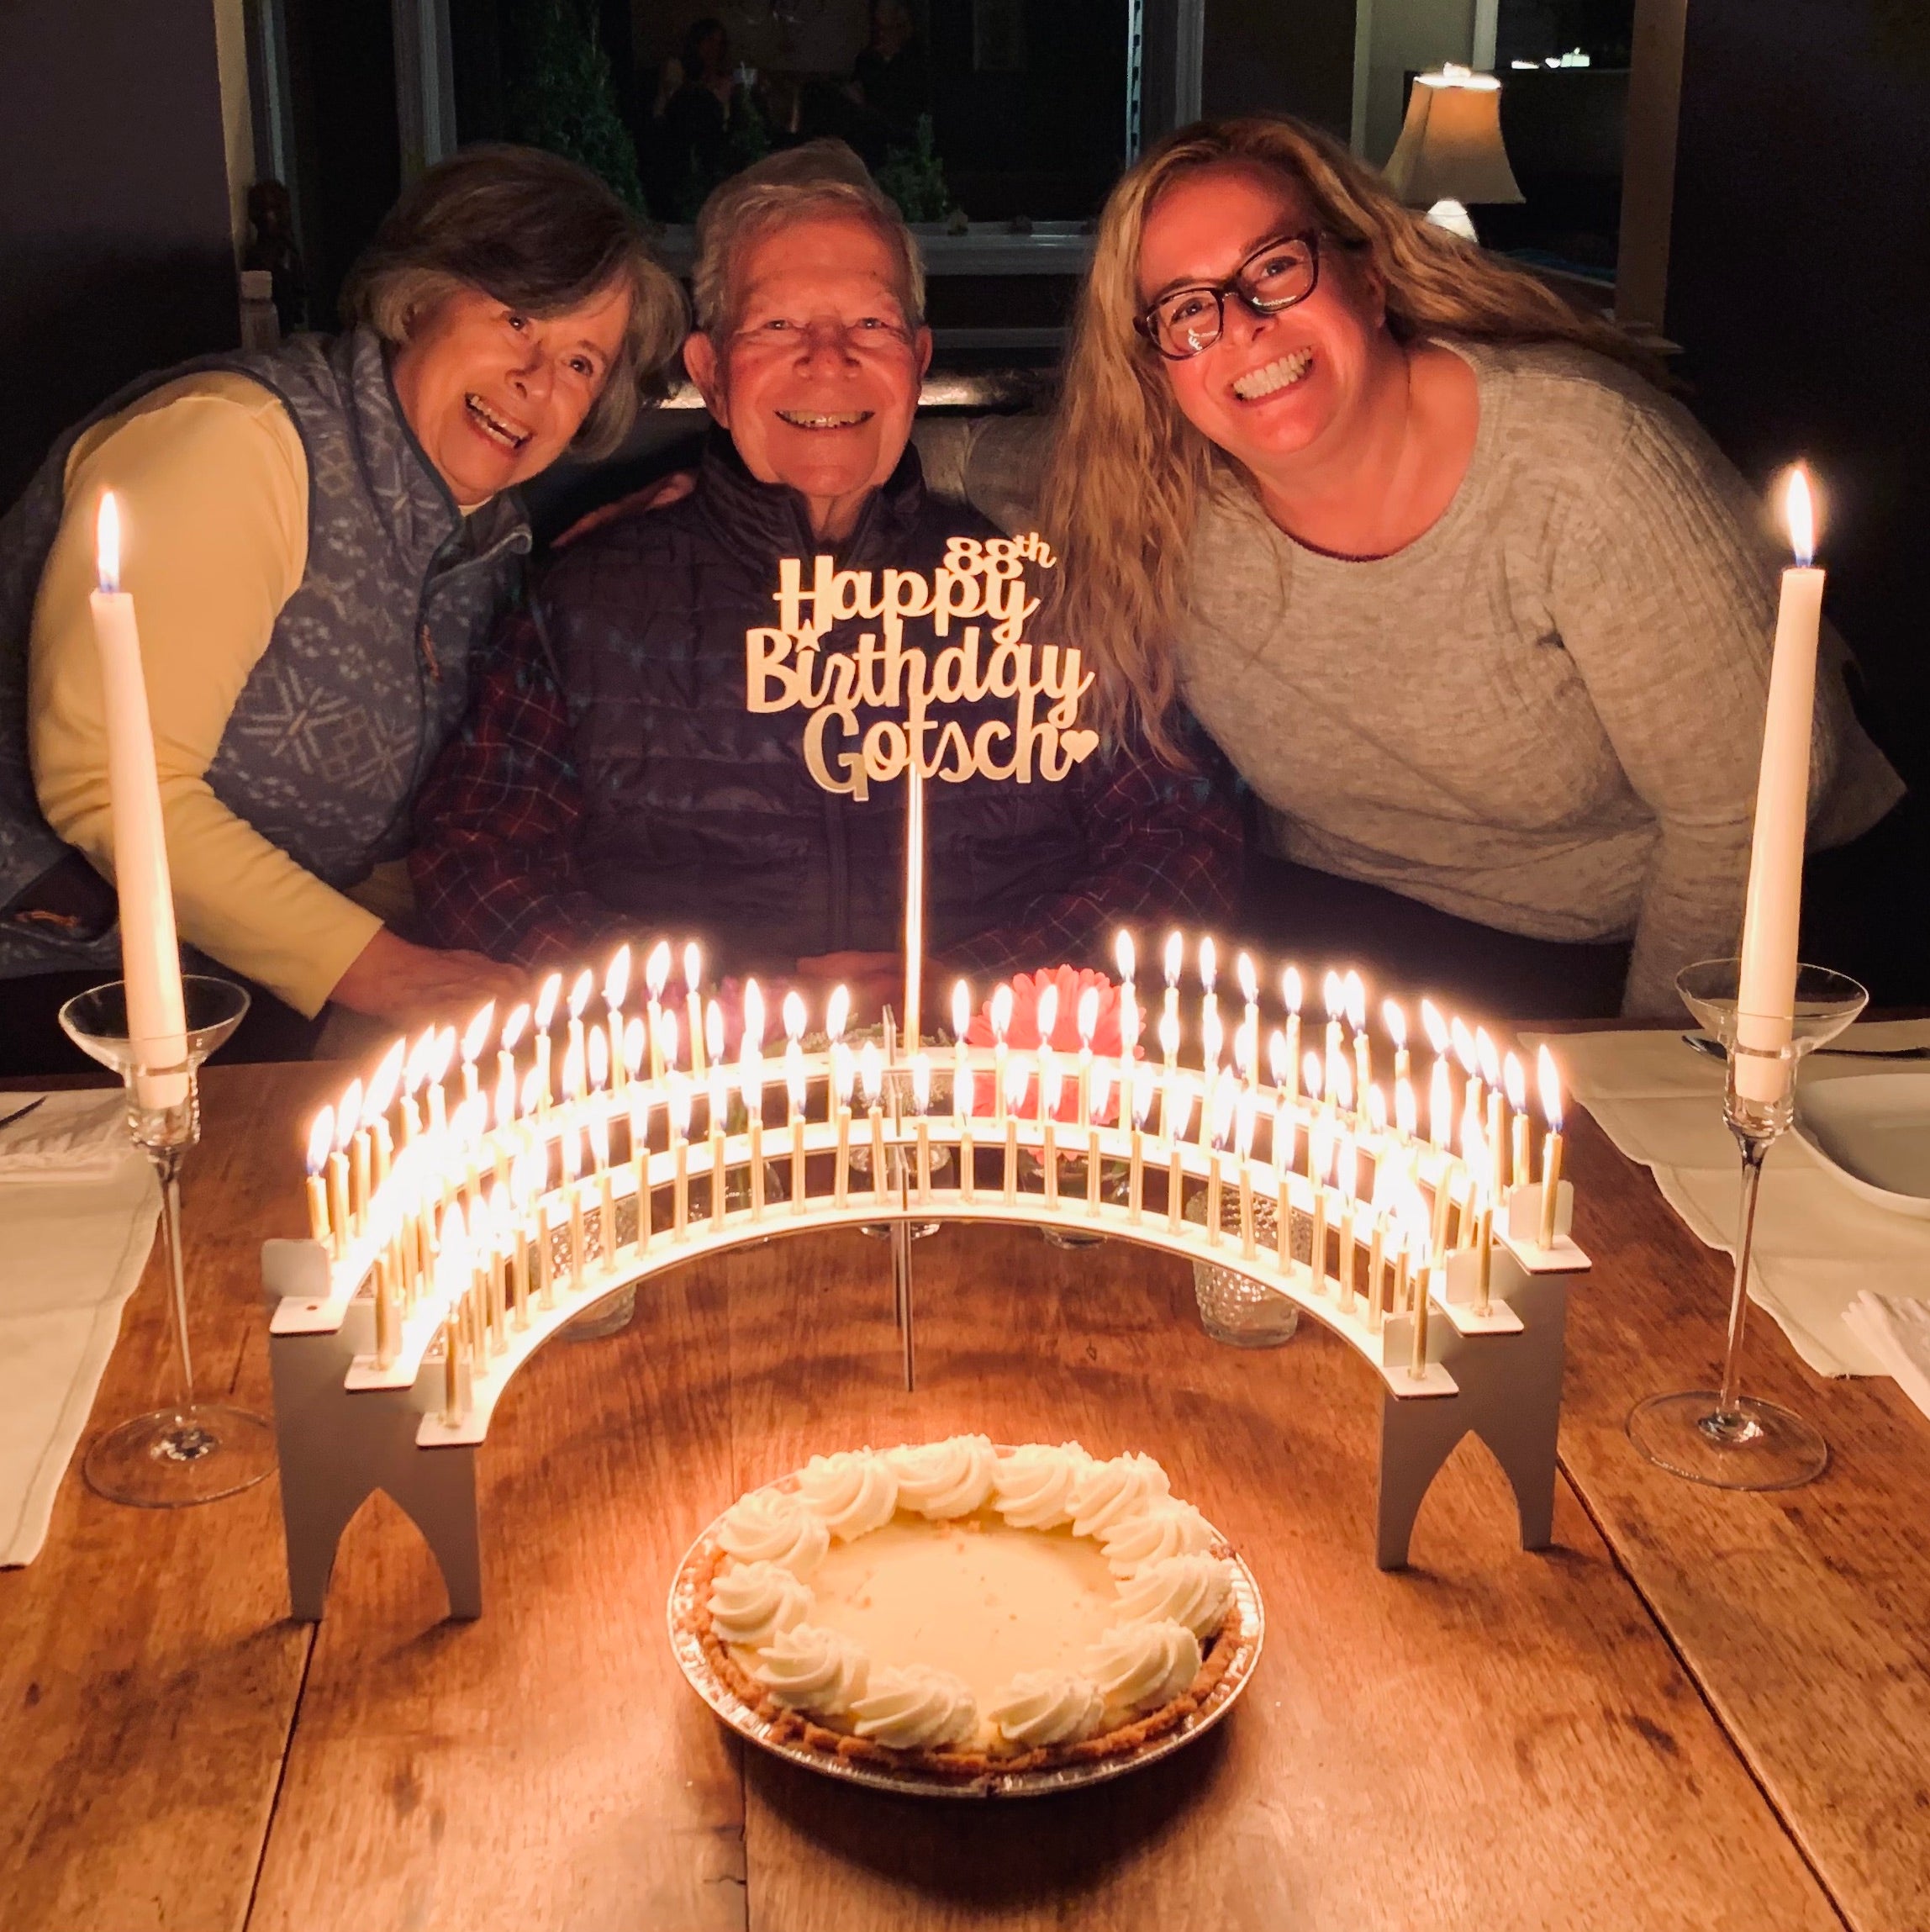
1527,1014,1930,1375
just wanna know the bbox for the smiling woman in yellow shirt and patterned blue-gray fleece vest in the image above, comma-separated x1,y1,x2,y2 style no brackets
0,147,684,1045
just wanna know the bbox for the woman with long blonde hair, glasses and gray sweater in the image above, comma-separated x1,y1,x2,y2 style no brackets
920,119,1901,1014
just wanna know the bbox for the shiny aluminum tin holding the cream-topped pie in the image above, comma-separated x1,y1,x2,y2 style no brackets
667,1468,1265,1798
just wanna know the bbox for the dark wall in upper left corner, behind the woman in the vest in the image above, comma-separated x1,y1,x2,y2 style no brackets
0,0,240,504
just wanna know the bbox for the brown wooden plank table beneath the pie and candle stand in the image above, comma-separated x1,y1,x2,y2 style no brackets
0,1064,1930,1932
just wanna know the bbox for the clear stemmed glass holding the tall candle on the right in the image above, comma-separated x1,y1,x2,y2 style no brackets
1628,960,1870,1490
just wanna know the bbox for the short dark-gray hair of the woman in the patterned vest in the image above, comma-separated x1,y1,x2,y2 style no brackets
342,143,686,456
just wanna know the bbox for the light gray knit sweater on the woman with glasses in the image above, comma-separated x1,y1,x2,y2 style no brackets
918,342,1903,1018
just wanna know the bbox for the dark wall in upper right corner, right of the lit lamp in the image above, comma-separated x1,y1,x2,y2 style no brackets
1667,0,1930,792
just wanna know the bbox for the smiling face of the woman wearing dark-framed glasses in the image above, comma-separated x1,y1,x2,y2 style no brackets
1140,162,1399,478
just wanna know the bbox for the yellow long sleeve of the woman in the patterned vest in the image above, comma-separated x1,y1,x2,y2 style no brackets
29,375,400,1014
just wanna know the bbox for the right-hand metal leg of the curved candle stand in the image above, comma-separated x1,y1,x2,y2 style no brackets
1375,1250,1569,1569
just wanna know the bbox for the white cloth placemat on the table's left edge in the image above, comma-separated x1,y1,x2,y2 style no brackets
0,1091,161,1565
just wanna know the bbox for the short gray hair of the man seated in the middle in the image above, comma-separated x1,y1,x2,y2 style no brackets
689,141,925,336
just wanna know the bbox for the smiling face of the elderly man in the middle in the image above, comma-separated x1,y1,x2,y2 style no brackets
684,214,931,539
